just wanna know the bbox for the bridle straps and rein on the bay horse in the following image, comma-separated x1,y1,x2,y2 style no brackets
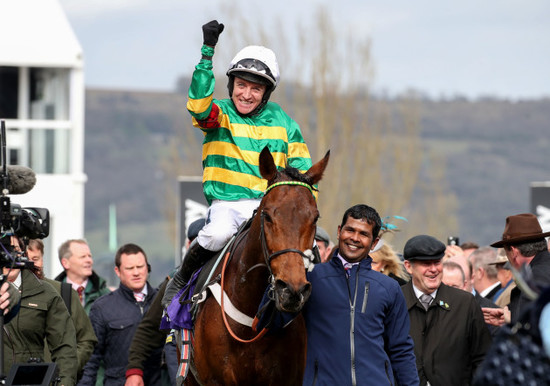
220,181,315,343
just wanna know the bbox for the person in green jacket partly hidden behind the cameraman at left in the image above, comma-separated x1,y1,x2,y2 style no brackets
27,239,97,379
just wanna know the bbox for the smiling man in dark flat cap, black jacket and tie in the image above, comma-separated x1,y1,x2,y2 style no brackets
401,235,491,386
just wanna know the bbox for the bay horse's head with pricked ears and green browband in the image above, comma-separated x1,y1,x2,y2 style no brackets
259,148,330,312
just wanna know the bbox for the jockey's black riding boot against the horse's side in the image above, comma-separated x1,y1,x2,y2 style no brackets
162,240,216,307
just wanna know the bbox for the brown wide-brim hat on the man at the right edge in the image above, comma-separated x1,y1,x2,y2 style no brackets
491,213,550,248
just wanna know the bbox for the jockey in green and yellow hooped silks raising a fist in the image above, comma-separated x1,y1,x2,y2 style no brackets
162,20,312,306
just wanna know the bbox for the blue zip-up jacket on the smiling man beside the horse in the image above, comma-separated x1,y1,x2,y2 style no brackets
303,250,418,385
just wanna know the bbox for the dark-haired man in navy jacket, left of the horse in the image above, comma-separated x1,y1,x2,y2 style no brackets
79,244,162,386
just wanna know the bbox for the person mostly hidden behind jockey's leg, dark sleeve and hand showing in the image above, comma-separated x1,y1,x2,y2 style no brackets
126,218,205,386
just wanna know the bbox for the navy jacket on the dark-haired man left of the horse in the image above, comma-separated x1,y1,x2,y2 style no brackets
78,283,162,386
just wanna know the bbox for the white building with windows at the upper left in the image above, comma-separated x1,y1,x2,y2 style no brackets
0,0,86,277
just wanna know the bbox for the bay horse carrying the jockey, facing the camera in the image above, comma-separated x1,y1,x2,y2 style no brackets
185,148,330,385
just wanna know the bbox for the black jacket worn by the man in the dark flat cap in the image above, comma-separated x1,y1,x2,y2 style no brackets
401,280,491,386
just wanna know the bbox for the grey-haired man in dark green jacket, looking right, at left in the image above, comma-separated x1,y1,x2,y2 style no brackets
55,239,111,314
